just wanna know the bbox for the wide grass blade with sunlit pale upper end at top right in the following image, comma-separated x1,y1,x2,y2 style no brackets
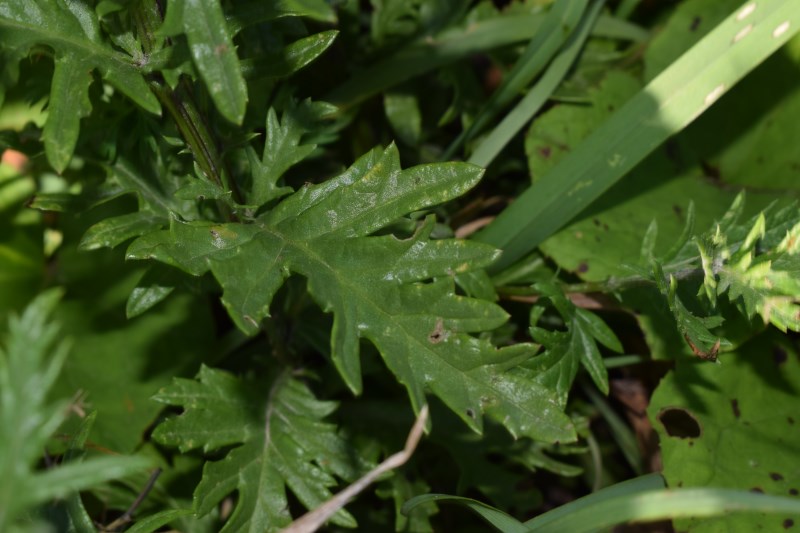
473,0,800,270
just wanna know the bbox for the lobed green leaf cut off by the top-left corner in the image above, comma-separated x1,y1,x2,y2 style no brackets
0,0,161,172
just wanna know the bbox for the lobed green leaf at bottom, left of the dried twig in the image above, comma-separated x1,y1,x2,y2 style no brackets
154,366,367,533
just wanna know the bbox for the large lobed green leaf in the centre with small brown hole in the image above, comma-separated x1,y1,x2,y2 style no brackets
128,146,574,442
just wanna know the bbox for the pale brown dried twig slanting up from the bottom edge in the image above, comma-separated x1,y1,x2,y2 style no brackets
282,405,428,533
